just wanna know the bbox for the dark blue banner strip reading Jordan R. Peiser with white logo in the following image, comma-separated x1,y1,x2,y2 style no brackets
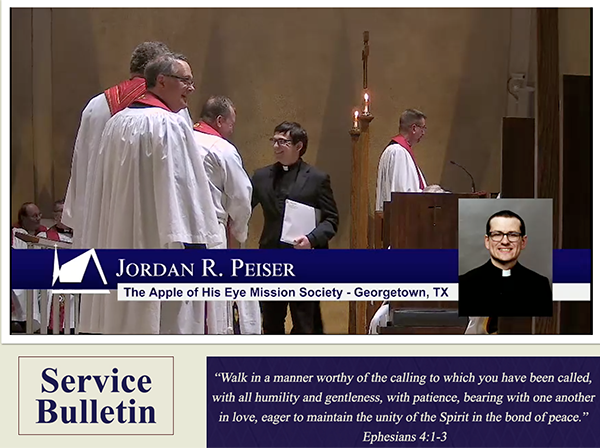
11,249,591,290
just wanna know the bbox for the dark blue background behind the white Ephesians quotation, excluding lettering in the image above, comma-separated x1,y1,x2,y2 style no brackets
207,356,600,448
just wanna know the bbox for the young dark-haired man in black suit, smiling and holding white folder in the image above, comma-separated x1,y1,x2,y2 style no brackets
252,121,338,334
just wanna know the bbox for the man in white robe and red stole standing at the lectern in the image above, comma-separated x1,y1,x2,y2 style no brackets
375,109,443,211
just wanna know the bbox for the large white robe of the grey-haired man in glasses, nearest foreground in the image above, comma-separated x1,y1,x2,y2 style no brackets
80,92,223,334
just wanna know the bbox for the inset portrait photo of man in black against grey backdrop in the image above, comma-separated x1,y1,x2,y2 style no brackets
458,199,552,317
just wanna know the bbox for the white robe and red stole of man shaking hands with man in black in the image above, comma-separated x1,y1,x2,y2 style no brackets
194,122,261,334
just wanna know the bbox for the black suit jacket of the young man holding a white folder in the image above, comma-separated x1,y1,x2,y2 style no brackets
252,160,338,249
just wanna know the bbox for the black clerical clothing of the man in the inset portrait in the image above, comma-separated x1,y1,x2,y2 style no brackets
458,261,552,317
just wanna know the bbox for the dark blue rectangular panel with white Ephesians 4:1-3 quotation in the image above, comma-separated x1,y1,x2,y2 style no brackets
207,357,600,448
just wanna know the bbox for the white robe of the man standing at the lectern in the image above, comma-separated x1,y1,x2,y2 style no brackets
375,137,427,211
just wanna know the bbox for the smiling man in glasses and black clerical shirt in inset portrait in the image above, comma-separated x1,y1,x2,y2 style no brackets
458,210,552,317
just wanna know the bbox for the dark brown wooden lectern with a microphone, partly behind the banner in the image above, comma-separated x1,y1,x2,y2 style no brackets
375,193,489,334
